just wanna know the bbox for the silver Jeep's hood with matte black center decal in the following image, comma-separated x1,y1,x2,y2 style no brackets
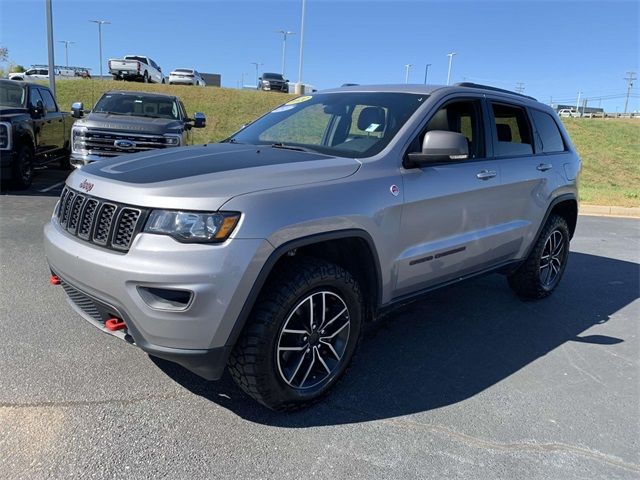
67,143,361,211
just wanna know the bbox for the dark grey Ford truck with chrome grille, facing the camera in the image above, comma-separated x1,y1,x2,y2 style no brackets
71,91,206,167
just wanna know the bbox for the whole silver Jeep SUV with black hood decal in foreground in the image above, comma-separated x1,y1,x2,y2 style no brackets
45,84,580,410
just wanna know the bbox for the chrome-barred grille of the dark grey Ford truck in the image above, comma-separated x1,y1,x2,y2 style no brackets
73,129,174,157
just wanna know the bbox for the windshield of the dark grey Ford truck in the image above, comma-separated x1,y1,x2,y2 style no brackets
93,93,180,120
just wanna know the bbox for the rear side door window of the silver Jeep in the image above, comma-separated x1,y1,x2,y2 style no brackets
491,103,533,157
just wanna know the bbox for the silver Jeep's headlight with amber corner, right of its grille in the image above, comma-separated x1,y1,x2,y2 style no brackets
144,210,240,243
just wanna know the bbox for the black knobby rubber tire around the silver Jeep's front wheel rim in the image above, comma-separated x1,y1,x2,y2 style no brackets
228,258,364,411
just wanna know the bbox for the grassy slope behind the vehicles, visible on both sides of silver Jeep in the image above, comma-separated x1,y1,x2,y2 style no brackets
52,80,640,206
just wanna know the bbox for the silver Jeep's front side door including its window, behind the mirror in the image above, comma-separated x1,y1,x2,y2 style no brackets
394,95,510,297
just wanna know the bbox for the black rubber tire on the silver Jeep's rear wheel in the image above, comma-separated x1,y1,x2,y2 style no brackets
508,214,570,300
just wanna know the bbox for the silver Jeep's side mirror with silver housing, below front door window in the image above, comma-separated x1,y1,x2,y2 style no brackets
405,130,469,168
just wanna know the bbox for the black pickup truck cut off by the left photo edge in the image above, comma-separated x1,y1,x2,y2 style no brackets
0,79,73,189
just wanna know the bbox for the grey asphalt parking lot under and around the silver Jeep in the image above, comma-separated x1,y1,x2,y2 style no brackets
0,168,640,479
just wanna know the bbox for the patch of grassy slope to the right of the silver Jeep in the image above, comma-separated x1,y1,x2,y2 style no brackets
562,118,640,207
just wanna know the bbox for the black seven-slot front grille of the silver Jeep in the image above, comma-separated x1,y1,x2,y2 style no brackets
57,187,148,252
